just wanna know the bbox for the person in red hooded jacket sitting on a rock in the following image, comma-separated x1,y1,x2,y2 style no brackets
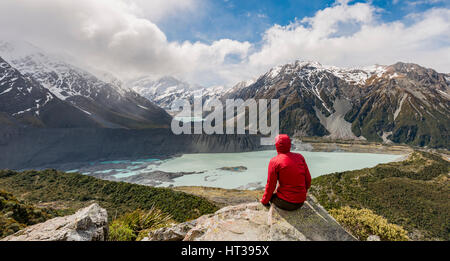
261,134,311,210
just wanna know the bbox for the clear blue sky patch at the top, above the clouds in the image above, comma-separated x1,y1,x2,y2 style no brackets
157,0,450,43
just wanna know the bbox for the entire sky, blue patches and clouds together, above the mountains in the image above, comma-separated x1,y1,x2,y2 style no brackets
0,0,450,86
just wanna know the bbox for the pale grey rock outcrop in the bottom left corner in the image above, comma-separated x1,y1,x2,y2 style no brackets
2,203,108,241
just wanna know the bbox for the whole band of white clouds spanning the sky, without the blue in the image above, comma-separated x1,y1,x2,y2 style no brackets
0,0,450,85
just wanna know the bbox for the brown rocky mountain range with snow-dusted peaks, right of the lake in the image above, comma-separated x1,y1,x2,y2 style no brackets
223,61,450,147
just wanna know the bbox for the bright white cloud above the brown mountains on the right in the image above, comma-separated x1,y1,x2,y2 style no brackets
244,1,450,80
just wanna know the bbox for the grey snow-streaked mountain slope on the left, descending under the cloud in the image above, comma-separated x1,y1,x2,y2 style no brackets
0,42,170,128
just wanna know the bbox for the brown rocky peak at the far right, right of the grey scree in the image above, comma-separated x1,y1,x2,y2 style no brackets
346,63,450,148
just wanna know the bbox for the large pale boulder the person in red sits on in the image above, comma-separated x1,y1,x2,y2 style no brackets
146,197,356,241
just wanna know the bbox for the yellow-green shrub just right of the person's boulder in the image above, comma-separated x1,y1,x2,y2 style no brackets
329,206,409,241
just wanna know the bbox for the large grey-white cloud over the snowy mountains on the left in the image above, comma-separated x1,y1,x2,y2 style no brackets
0,0,250,84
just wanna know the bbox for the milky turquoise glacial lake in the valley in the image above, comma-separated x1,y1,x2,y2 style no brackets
71,151,403,189
